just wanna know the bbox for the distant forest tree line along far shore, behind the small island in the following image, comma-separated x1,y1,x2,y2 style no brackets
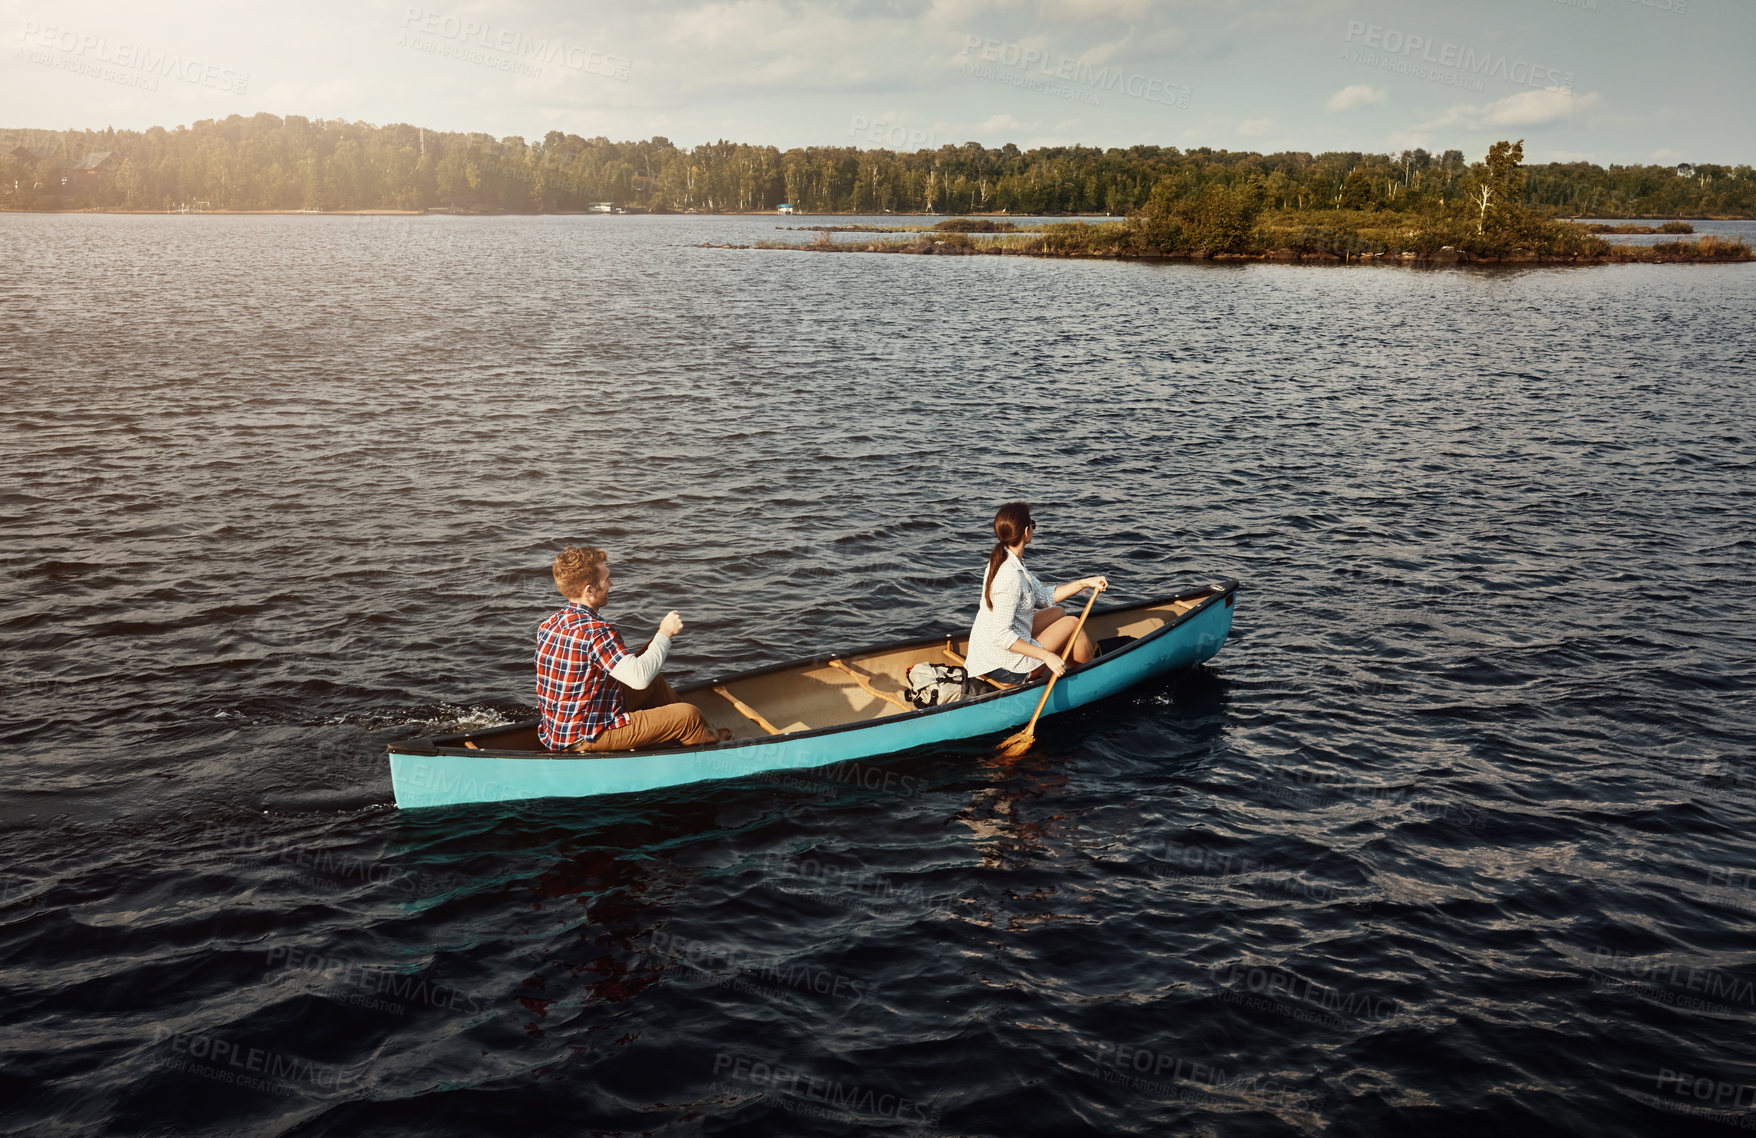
0,114,1756,216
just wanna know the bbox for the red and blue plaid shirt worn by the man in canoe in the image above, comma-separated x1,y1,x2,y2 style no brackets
537,602,632,750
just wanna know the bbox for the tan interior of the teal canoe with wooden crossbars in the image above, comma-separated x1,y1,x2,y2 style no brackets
434,592,1212,755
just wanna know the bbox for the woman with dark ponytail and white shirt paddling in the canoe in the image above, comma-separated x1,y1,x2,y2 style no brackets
964,502,1110,683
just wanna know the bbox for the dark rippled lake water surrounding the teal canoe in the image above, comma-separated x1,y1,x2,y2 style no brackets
0,214,1756,1138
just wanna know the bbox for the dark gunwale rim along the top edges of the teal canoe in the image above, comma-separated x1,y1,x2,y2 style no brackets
385,578,1238,760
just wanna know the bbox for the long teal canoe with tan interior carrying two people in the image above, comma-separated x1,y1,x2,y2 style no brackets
388,580,1238,808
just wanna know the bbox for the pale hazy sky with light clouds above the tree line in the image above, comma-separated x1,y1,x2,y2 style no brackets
0,0,1756,165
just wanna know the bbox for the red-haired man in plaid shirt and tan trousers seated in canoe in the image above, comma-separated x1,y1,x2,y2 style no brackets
537,546,715,752
